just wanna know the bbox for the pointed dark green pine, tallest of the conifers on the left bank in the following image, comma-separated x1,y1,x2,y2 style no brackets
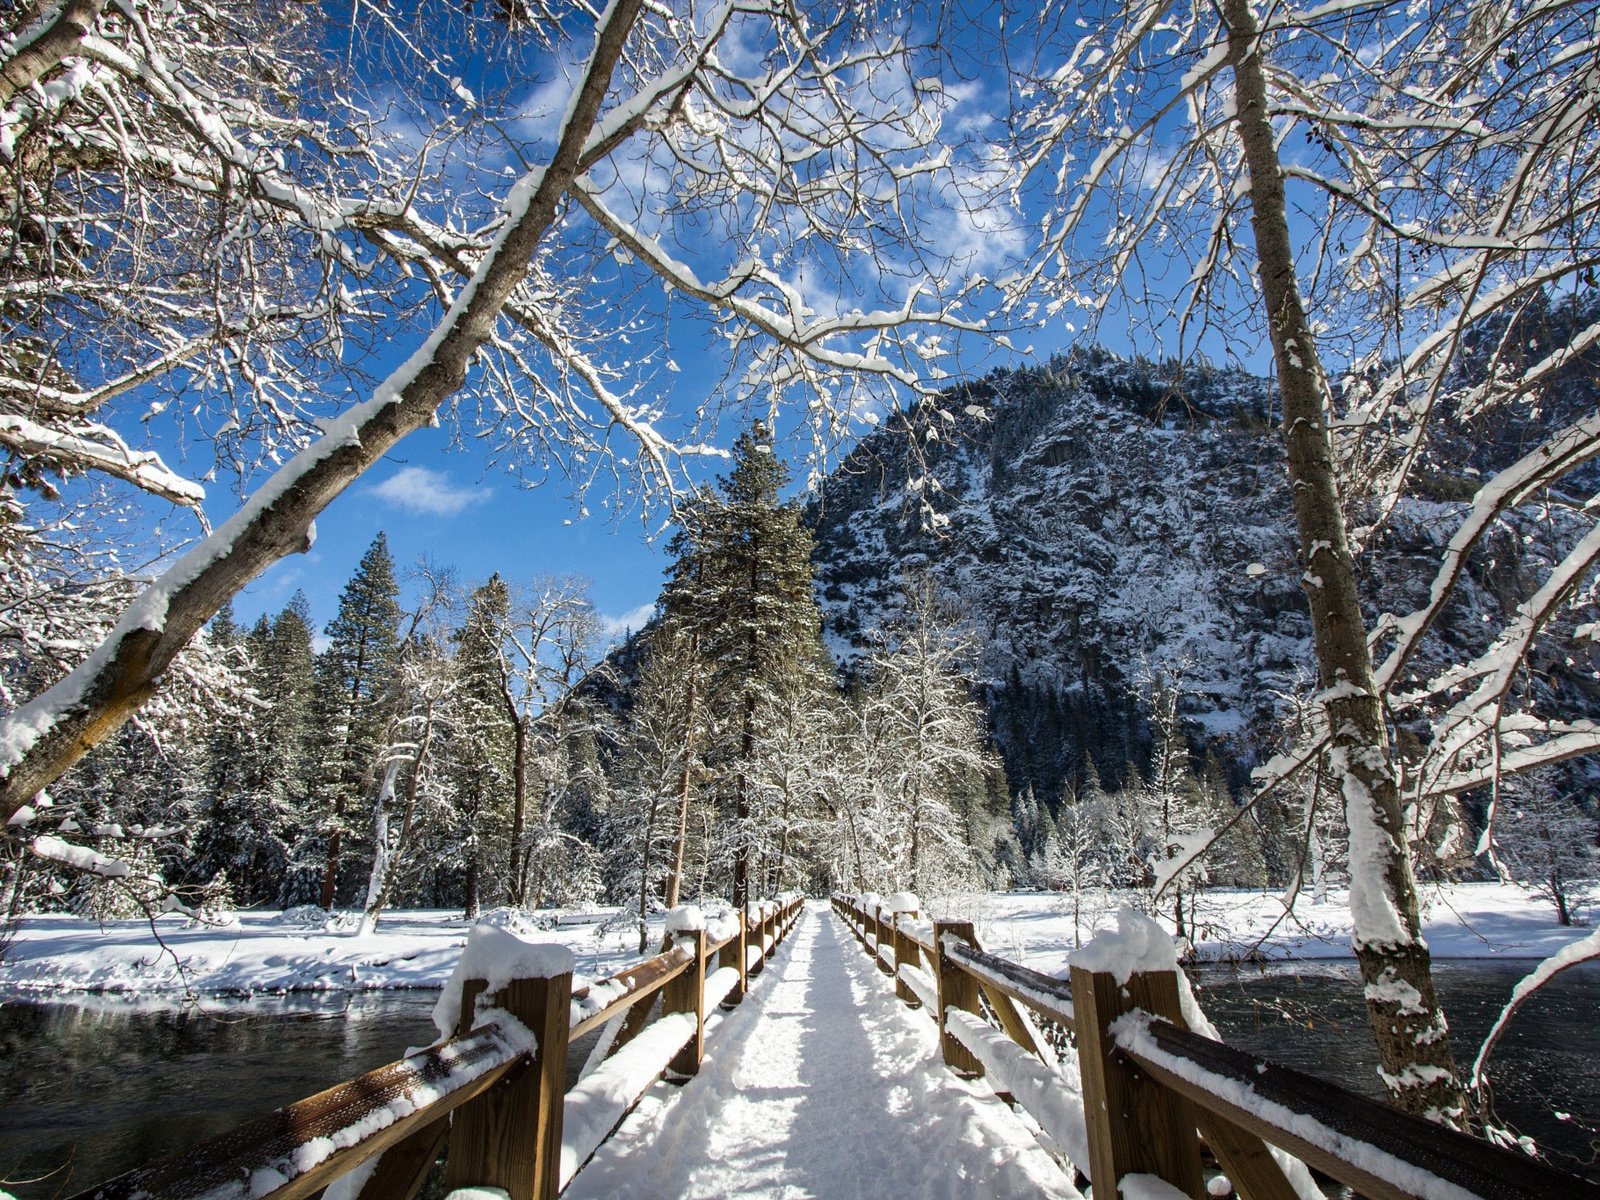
315,533,400,909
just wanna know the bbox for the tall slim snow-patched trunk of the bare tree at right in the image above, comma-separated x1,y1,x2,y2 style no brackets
1222,0,1464,1122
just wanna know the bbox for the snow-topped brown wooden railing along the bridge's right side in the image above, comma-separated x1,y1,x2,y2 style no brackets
834,893,1600,1200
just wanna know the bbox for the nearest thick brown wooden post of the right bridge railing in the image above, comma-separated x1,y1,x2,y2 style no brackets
1072,966,1205,1197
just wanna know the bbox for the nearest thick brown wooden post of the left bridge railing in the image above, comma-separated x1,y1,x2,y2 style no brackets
445,946,573,1200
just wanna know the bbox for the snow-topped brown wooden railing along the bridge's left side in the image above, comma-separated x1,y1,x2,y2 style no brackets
74,898,803,1200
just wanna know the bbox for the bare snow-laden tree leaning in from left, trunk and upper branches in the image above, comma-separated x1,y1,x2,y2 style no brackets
0,0,1011,818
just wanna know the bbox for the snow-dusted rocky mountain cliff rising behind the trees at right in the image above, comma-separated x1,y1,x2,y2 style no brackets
810,352,1597,809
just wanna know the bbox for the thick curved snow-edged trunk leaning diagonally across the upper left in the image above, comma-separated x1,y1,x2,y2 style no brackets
0,0,643,824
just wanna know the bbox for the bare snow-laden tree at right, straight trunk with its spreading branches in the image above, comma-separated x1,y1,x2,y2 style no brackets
1016,0,1600,1120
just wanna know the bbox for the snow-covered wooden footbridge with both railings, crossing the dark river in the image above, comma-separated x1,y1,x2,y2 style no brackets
68,896,1600,1200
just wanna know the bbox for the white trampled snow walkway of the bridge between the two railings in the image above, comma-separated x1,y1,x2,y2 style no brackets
563,904,1077,1200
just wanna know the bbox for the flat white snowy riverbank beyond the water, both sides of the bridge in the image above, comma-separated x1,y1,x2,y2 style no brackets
0,883,1589,1003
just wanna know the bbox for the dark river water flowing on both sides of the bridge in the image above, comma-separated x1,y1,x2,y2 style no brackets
0,962,1600,1200
